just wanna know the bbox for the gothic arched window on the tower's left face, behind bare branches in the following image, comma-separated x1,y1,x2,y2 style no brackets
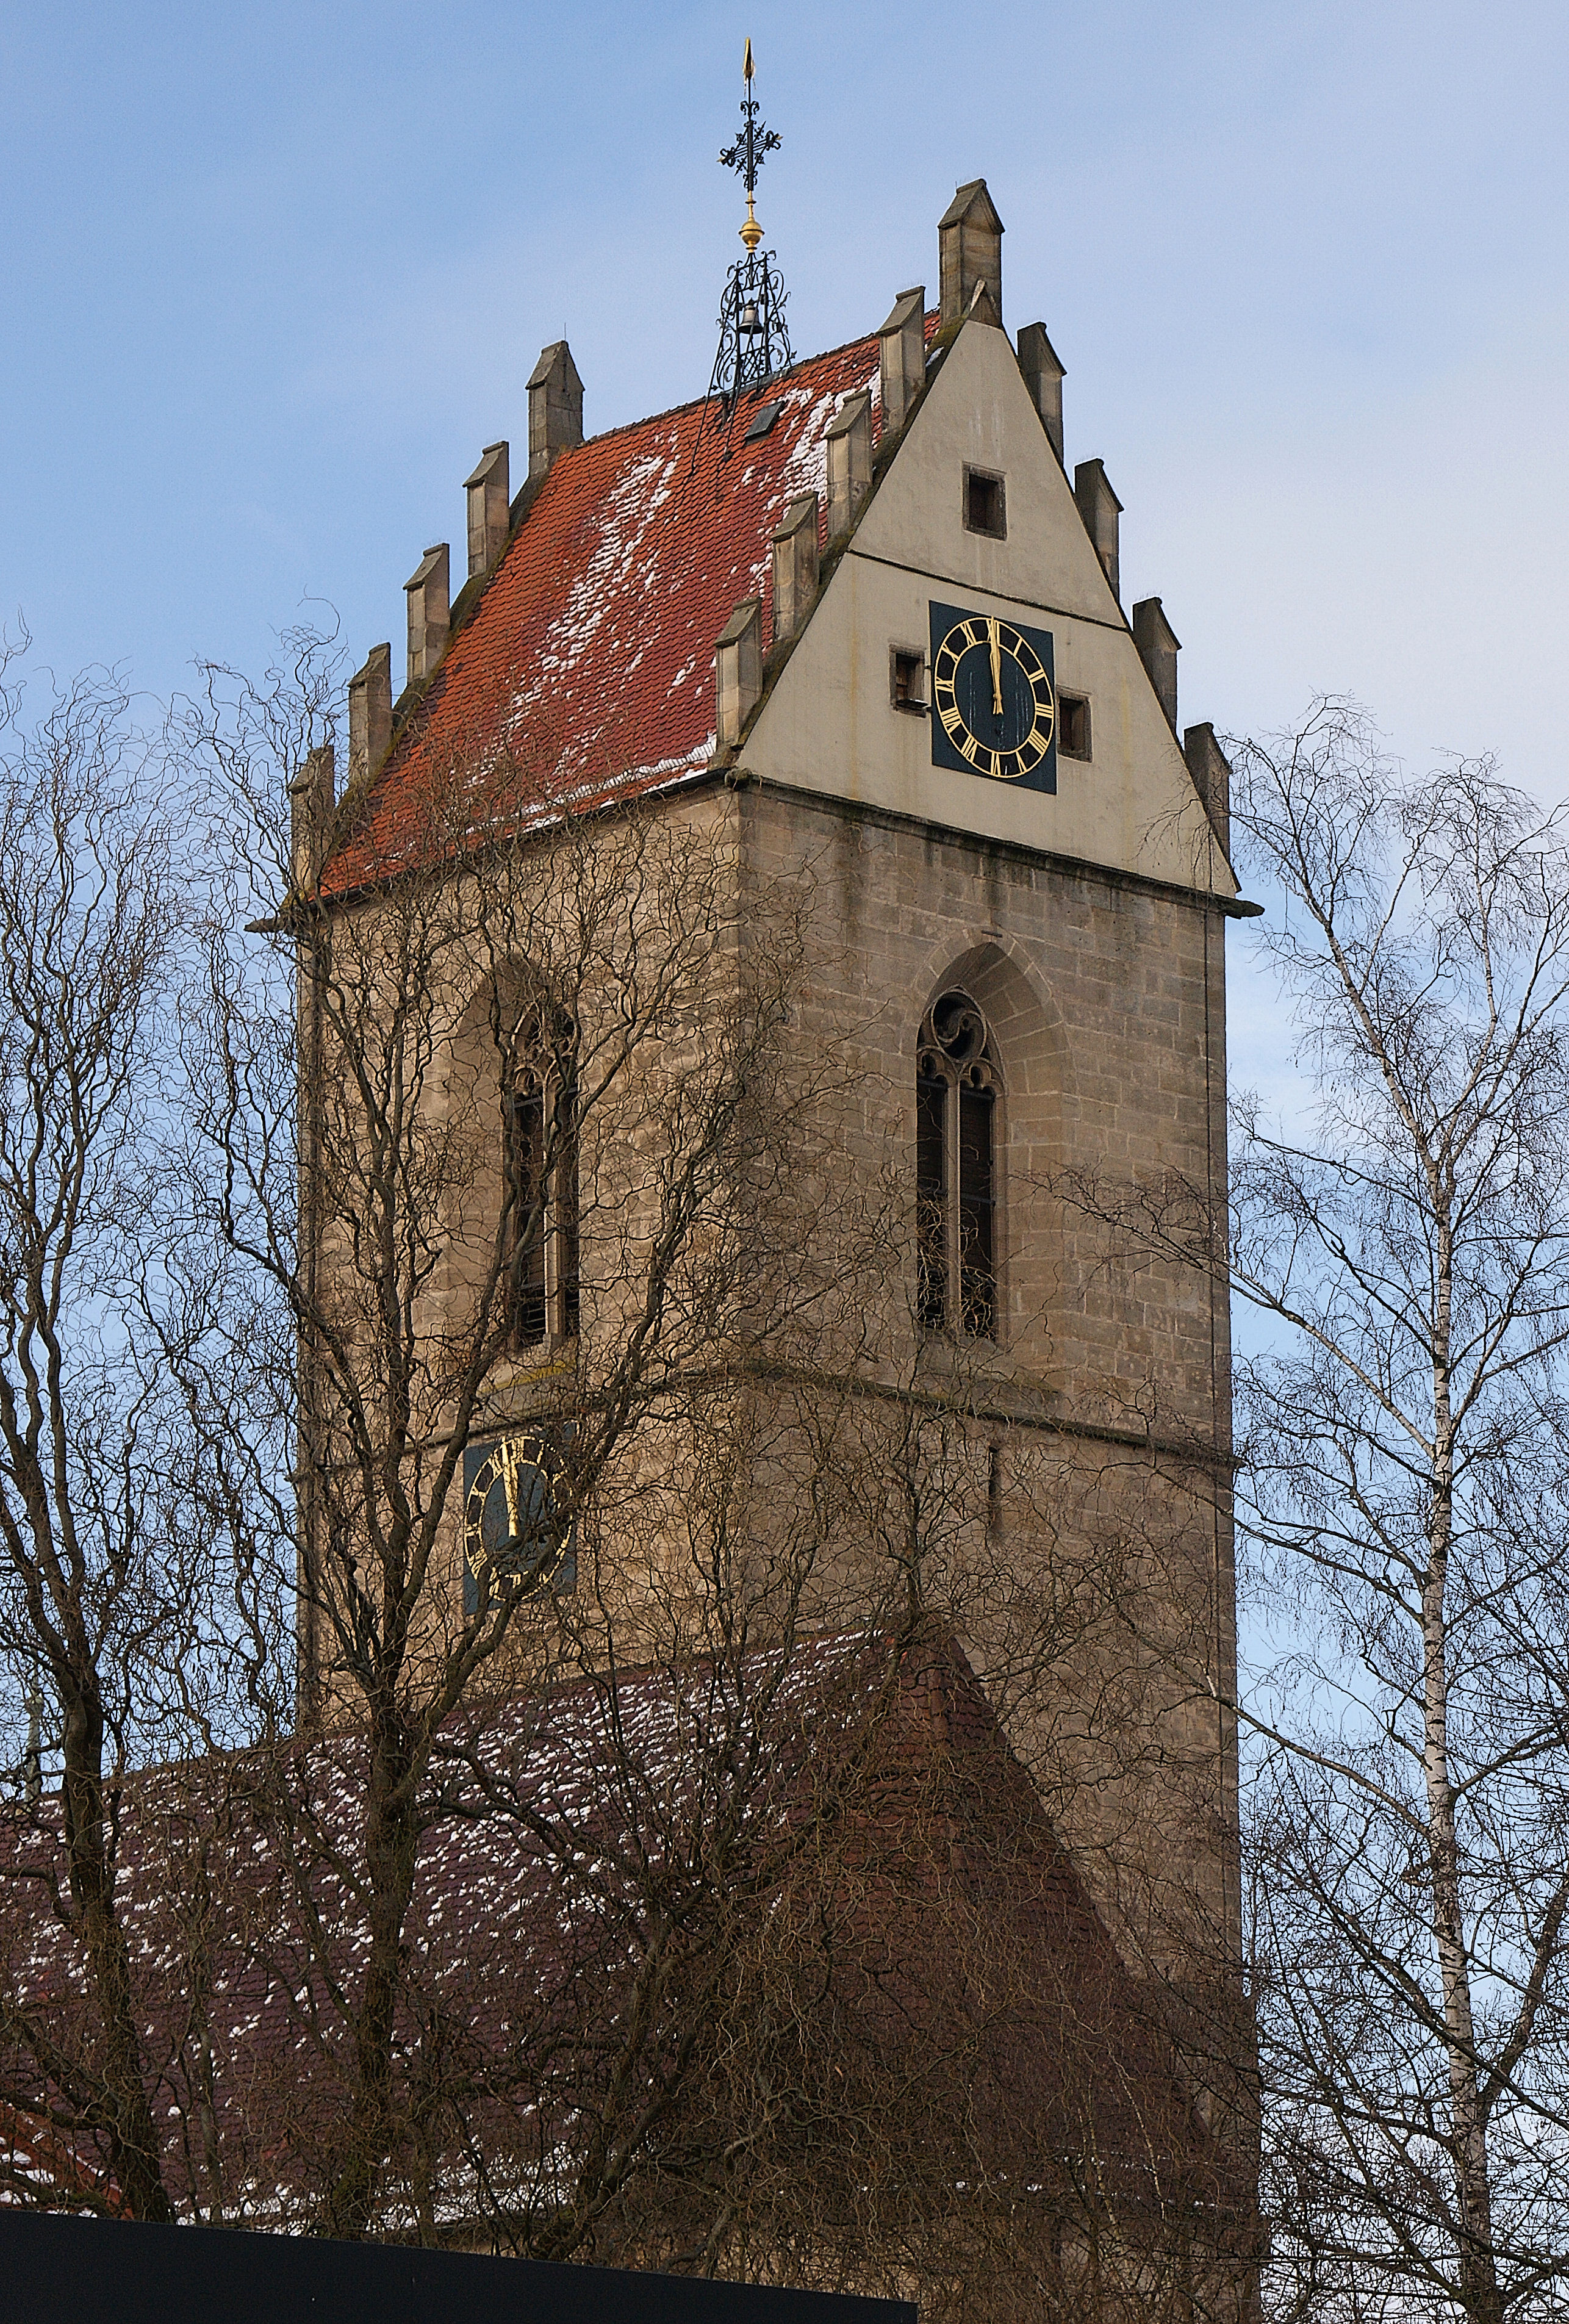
504,1009,579,1348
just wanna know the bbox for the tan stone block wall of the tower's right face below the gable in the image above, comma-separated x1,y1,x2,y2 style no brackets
742,788,1239,1968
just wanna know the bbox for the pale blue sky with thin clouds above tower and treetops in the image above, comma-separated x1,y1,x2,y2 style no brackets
0,0,1569,797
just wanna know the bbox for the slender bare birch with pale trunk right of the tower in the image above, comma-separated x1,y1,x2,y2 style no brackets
1083,700,1569,2324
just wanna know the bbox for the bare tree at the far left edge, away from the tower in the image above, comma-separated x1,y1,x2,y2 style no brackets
0,641,279,2220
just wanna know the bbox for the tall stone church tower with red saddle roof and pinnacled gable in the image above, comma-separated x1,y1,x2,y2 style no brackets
298,73,1253,2287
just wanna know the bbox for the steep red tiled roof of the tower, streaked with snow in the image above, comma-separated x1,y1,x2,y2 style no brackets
323,314,937,894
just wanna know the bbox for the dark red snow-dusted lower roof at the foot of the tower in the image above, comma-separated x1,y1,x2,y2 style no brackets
0,1634,1239,2224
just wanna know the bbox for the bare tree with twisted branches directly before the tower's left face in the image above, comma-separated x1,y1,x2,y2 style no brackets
153,622,1237,2298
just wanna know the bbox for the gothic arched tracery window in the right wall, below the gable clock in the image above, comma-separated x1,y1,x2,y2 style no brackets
916,988,1002,1339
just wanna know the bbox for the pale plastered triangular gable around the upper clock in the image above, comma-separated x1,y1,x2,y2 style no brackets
744,321,1237,897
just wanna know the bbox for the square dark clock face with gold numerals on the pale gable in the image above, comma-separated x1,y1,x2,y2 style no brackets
932,604,1058,790
